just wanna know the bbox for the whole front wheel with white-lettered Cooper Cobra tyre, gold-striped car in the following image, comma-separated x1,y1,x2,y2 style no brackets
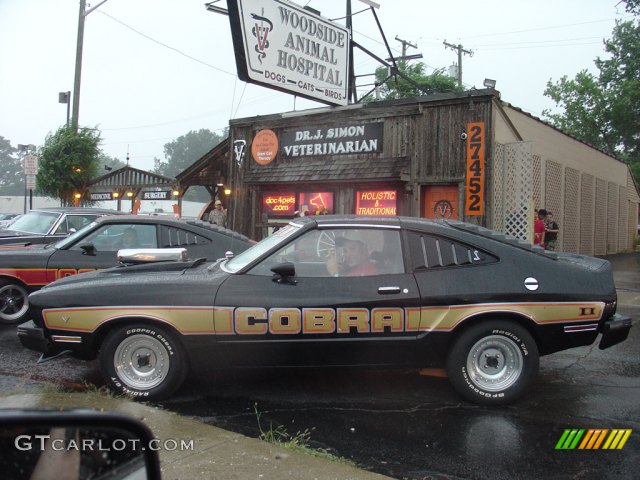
99,324,188,400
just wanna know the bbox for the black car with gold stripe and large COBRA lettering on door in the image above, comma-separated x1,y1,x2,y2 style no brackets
18,216,631,404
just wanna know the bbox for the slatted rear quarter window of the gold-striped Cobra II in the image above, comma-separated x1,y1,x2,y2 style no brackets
409,232,498,270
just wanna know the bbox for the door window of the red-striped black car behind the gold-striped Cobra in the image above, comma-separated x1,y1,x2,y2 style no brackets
71,223,158,252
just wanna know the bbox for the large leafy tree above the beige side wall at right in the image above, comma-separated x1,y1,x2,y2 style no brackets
543,4,640,182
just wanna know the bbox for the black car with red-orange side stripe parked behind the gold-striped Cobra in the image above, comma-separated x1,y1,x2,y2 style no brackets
0,215,252,323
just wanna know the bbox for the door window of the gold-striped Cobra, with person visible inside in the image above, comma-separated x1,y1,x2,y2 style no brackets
249,228,405,277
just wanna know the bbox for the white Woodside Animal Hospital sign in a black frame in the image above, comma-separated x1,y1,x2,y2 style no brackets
227,0,350,105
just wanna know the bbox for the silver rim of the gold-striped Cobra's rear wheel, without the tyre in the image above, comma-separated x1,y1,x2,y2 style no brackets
467,335,524,392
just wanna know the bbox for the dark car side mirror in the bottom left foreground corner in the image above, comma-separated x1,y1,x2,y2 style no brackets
0,410,161,479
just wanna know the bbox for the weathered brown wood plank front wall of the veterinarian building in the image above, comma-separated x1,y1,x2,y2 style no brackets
228,96,493,239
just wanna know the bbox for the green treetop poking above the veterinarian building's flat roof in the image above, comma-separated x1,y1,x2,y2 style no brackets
367,60,462,101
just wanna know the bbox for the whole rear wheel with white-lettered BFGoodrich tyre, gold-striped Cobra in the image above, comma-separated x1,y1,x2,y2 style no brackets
447,320,539,405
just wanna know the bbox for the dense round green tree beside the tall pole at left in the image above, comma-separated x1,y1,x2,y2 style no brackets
36,126,101,205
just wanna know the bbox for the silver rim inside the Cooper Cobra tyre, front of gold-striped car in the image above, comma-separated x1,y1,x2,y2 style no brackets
113,335,170,390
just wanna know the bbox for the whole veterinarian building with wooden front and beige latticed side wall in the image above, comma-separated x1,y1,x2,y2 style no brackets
191,89,640,255
